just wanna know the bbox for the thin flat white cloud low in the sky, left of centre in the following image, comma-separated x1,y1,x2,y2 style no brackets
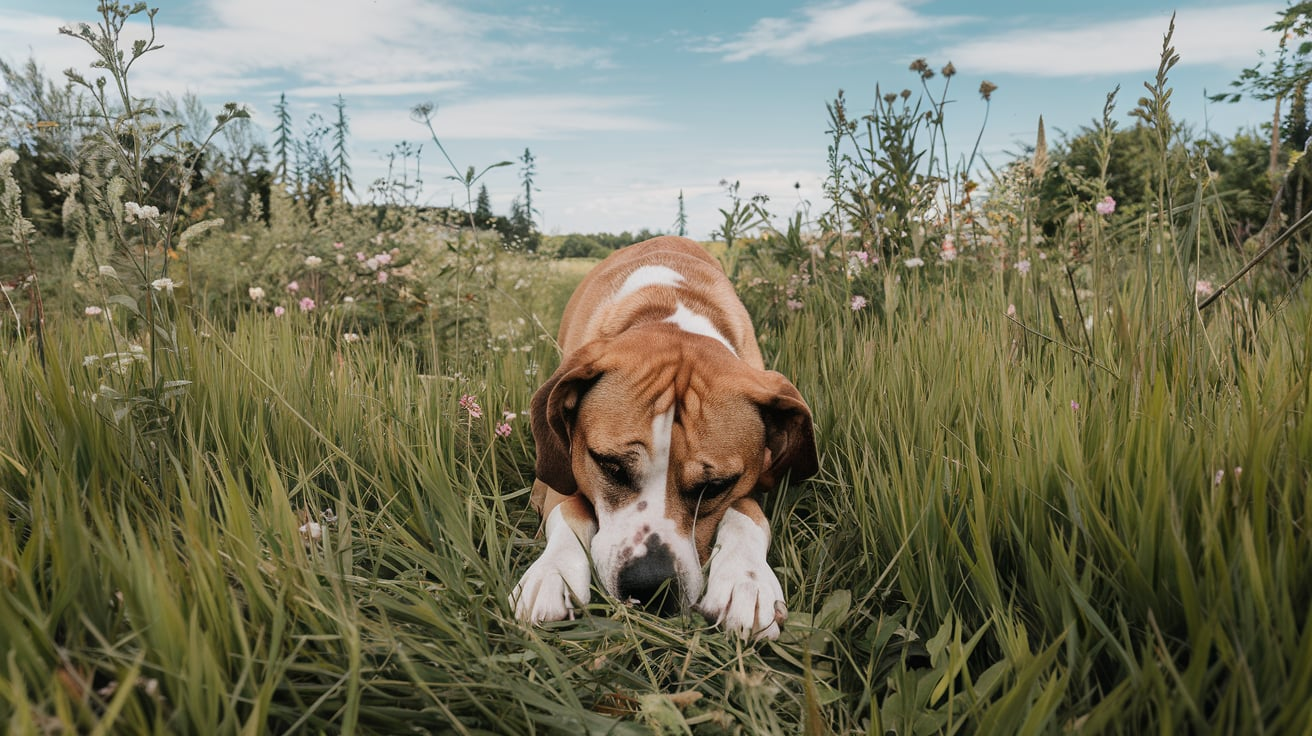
350,94,669,142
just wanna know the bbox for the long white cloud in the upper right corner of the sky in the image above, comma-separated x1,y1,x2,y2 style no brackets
942,4,1274,76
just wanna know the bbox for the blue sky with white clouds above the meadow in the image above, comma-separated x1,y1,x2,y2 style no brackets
0,0,1284,237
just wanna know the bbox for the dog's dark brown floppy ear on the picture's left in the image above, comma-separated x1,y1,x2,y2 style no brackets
529,342,601,496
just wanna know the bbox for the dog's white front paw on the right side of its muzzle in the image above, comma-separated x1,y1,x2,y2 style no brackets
697,509,789,639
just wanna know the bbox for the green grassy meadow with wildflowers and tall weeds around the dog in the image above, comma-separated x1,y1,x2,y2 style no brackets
0,2,1312,735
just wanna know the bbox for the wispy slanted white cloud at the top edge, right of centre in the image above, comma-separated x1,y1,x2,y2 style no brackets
701,0,964,62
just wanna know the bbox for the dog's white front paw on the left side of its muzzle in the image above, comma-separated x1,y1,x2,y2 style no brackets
510,535,592,626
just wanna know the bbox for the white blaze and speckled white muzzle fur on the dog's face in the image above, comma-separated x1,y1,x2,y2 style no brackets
592,407,702,603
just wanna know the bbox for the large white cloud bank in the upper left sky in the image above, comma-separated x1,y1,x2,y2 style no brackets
0,0,606,97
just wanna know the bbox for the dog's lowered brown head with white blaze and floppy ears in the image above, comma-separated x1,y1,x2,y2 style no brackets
531,325,817,613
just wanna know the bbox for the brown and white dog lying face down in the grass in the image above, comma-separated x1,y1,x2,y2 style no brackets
510,237,817,639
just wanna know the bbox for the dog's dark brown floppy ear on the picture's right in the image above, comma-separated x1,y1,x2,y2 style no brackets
750,370,820,491
